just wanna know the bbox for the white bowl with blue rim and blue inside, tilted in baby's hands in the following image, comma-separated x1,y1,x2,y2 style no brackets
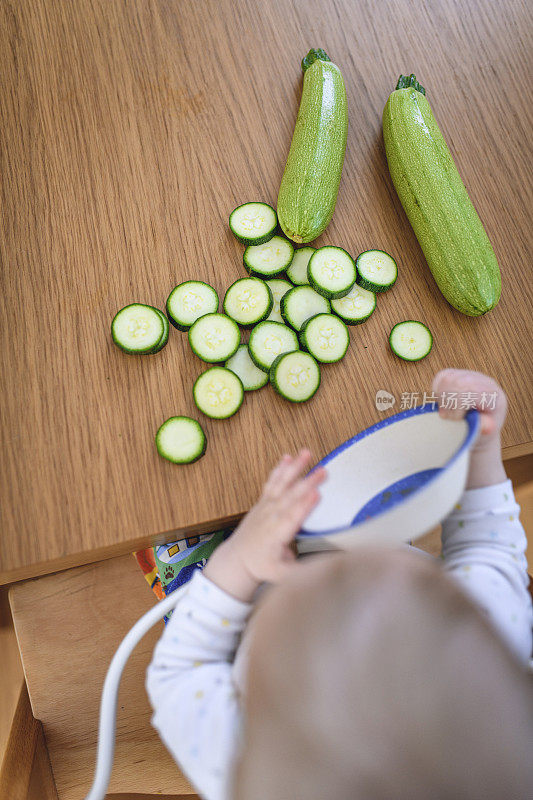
297,405,479,553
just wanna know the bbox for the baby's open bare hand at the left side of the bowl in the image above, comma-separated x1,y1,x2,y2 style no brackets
204,450,326,601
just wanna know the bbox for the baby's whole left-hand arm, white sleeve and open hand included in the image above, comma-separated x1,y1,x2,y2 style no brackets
146,451,324,800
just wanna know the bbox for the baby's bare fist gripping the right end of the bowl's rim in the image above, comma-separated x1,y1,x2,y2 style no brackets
433,369,507,489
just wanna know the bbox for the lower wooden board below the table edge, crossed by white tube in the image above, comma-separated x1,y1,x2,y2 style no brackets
9,555,196,800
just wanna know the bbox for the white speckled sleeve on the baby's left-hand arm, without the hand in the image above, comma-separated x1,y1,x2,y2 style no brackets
146,570,252,800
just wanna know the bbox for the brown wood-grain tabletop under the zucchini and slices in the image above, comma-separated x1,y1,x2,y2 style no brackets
0,0,533,582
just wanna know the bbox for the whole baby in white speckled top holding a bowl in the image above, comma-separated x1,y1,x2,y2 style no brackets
147,370,533,800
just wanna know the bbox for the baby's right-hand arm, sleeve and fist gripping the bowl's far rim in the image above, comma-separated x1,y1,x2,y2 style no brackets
433,370,533,662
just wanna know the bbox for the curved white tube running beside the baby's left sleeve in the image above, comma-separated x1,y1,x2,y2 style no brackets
85,586,187,800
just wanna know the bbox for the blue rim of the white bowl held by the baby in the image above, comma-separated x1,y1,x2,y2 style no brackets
298,404,480,538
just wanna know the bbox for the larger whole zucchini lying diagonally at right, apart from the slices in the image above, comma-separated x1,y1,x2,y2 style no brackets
383,75,501,317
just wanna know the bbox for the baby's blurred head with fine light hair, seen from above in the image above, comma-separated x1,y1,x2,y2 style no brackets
235,550,533,800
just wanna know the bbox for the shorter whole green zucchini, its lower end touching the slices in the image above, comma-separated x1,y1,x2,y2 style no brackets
278,50,348,244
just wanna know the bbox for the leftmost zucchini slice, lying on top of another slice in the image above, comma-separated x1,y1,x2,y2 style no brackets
111,303,165,354
